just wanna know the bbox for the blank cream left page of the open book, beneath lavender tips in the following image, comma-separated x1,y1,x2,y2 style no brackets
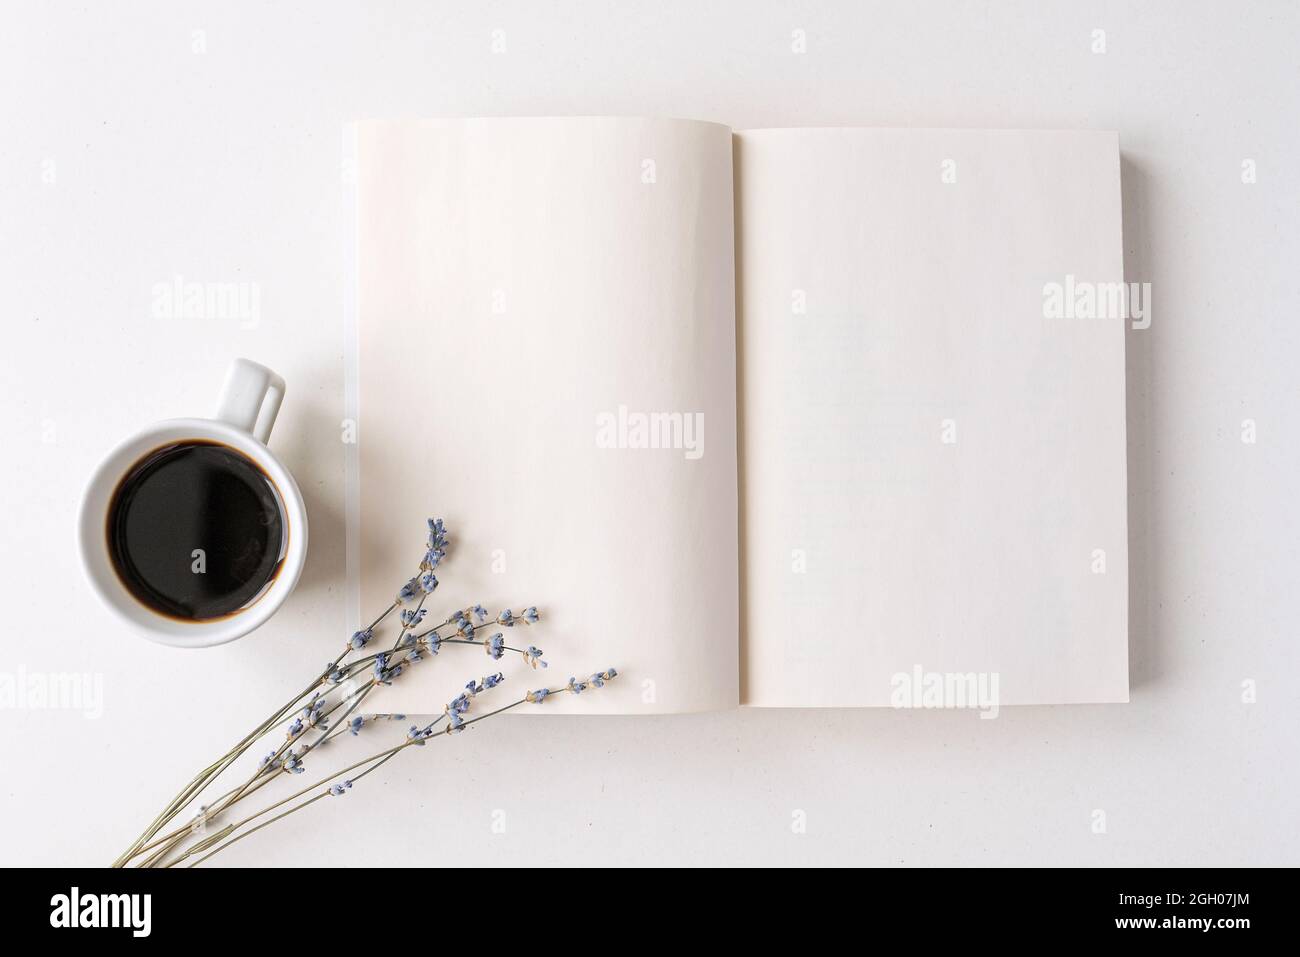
358,118,740,713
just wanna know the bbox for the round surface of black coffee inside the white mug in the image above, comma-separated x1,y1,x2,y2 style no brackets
108,441,286,622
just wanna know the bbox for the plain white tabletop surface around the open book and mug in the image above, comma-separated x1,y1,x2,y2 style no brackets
0,3,1300,866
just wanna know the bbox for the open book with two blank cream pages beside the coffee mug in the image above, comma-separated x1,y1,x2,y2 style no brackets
356,118,1128,713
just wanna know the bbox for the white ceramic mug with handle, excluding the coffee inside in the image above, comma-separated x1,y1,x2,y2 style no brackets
78,359,307,648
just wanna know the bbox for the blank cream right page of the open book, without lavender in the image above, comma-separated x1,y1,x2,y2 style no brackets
736,129,1128,707
